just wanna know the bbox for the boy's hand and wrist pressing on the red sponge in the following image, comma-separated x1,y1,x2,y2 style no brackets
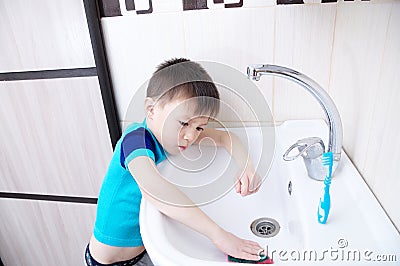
213,229,263,260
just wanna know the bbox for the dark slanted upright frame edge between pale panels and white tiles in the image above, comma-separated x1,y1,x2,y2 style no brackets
83,0,121,149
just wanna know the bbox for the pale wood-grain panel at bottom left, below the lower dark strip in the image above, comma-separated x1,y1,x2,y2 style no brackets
0,199,96,266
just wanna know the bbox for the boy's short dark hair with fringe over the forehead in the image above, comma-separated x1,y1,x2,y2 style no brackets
146,58,220,117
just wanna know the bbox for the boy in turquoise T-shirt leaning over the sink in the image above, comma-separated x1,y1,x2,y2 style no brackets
85,58,262,265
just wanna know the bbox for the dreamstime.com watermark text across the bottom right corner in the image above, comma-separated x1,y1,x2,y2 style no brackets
264,238,398,262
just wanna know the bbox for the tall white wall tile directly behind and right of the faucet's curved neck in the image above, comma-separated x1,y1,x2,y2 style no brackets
330,3,392,175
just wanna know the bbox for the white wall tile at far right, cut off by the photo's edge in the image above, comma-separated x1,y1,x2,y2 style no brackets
361,2,400,227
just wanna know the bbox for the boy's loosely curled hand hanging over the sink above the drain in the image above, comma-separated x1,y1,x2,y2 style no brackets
235,161,262,196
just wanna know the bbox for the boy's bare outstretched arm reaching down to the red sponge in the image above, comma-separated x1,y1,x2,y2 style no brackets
128,156,262,260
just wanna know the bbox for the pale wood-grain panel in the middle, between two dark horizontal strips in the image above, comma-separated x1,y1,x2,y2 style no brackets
0,77,112,197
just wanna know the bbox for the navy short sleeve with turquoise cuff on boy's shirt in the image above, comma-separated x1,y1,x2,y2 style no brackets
120,127,156,169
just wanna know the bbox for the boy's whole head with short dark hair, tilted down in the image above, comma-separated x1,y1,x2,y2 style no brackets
145,58,219,154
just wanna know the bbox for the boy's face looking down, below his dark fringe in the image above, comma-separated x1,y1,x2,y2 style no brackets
147,98,209,154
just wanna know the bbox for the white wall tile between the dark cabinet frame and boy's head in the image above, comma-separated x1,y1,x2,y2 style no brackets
101,13,185,120
